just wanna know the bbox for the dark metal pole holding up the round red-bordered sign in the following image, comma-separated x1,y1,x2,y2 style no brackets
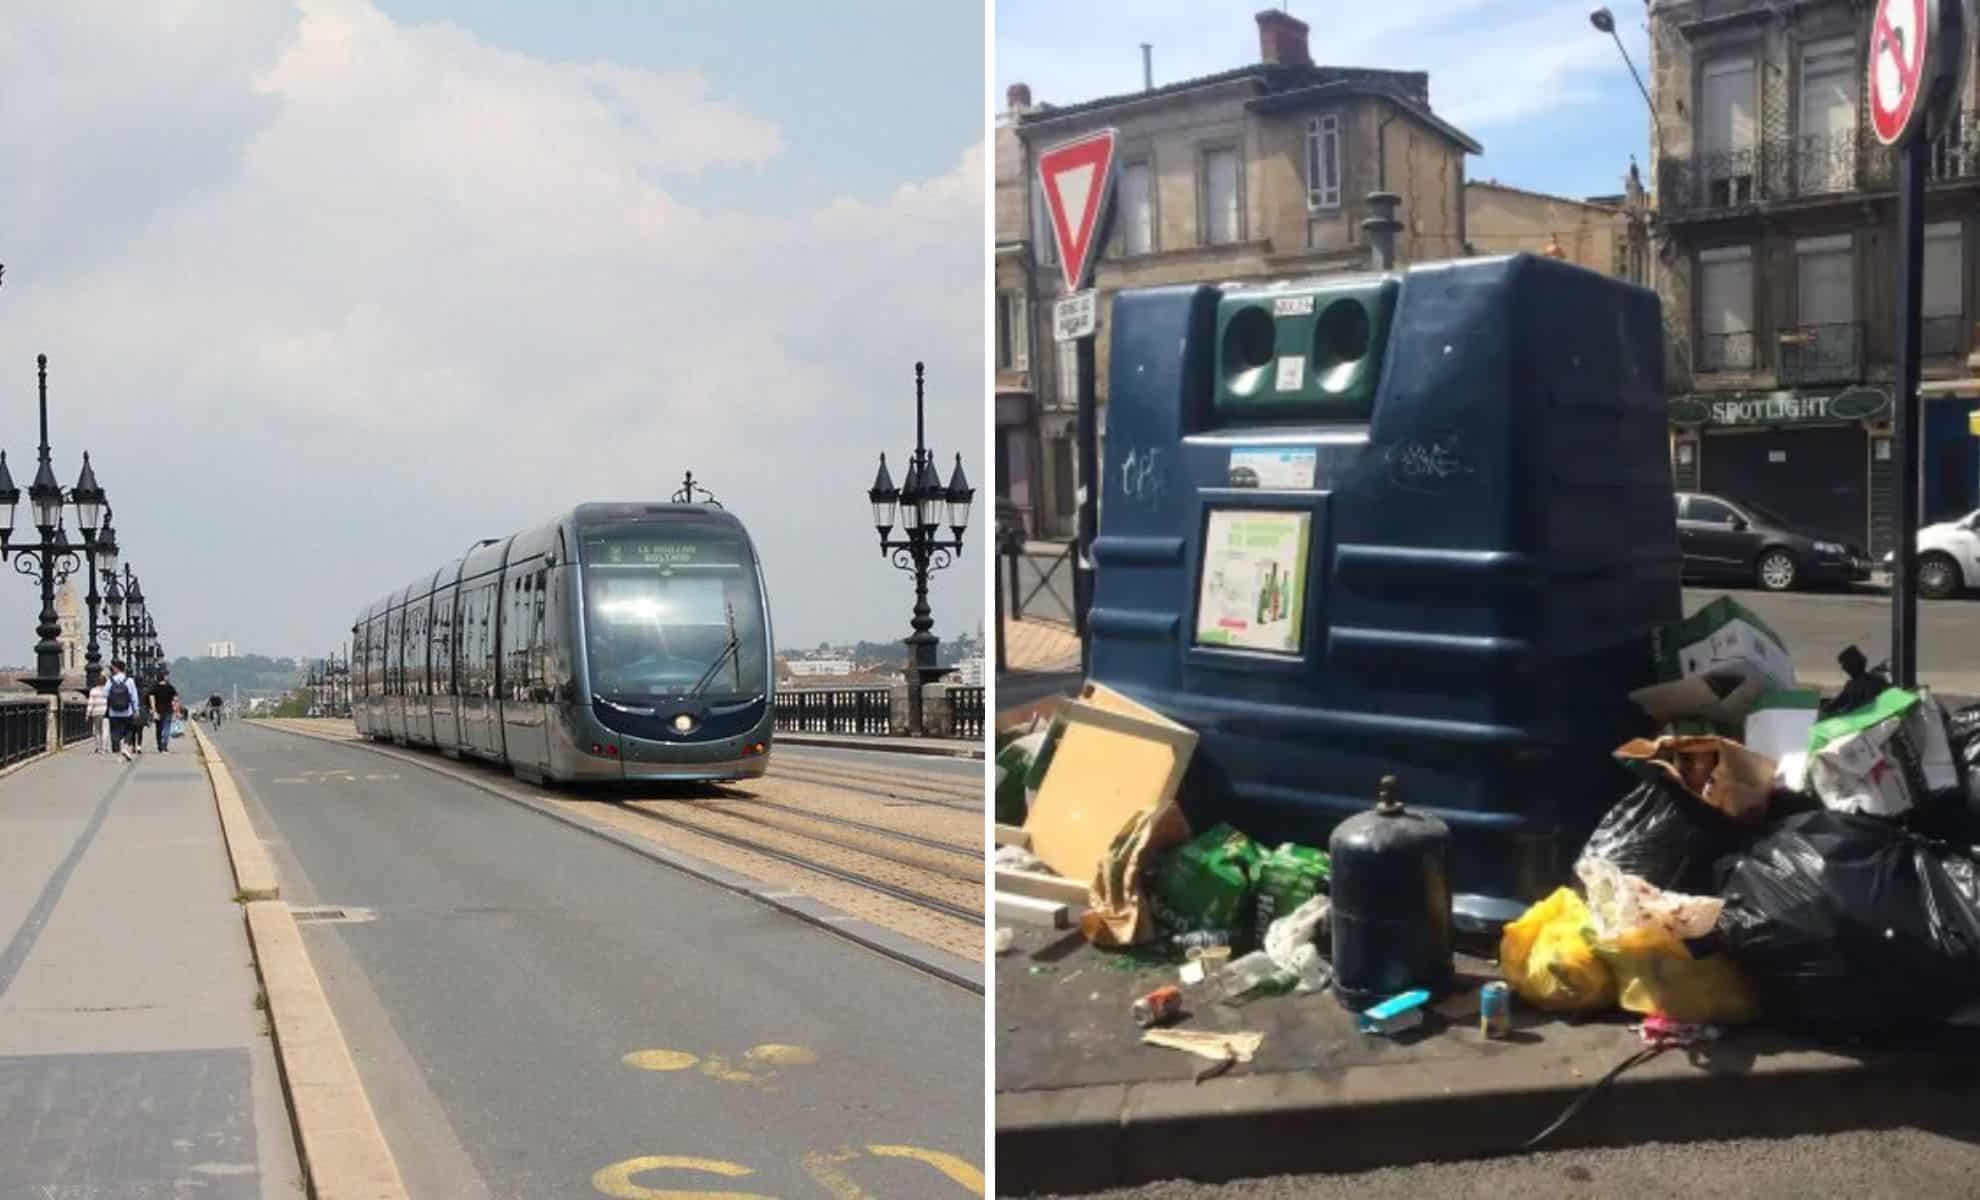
1891,137,1927,687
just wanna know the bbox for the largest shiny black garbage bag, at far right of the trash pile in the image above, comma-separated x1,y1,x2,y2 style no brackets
1717,812,1980,1034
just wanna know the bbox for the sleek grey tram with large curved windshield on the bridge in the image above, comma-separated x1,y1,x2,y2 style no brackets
350,497,776,782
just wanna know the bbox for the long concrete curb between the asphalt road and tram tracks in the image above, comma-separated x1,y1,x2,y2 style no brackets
255,721,984,996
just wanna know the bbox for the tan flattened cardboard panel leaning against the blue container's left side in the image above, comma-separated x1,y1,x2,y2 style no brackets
1024,701,1196,879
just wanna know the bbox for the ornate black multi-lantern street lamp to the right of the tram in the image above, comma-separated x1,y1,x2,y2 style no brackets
867,362,976,737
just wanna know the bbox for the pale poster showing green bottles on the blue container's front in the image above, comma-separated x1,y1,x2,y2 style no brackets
1196,509,1313,653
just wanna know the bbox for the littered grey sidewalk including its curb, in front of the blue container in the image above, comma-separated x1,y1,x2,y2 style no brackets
996,925,1980,1196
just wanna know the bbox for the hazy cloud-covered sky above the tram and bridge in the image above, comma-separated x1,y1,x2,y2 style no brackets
0,0,992,663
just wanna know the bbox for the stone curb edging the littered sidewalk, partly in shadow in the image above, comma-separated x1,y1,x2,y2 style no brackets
996,1040,1980,1196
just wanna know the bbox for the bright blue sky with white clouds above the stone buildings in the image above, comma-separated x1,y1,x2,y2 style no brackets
994,0,1651,196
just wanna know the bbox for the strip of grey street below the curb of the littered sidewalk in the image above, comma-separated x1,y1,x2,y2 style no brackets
1061,1119,1980,1200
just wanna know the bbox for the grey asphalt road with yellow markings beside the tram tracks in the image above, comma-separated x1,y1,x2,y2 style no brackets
216,723,984,1200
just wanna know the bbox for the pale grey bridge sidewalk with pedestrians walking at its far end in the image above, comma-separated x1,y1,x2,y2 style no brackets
0,739,303,1200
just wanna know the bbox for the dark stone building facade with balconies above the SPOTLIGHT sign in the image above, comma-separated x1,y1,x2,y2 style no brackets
1647,0,1980,554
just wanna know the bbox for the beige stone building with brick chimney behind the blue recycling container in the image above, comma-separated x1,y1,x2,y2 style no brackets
994,10,1481,537
